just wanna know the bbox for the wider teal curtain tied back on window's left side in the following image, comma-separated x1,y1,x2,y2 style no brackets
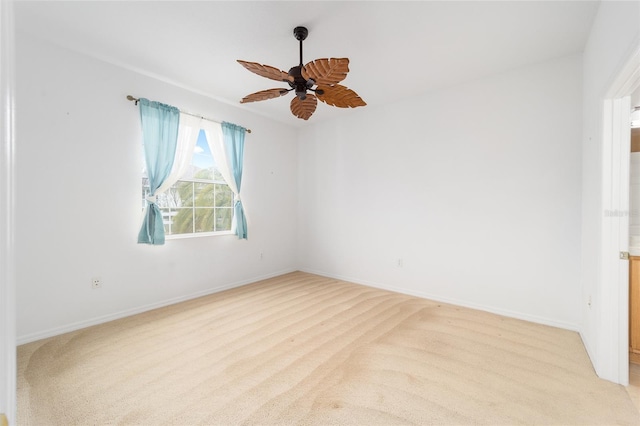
138,99,180,245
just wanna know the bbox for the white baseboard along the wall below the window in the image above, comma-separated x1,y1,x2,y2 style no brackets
17,268,297,345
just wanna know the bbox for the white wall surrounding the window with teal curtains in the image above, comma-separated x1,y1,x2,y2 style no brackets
16,34,297,343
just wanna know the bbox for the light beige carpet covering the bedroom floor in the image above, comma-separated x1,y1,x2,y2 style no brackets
18,272,640,426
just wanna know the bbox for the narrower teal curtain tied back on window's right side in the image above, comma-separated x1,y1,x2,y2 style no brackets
222,122,247,240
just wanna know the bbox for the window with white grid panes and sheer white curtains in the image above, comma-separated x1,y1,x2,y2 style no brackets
142,130,234,236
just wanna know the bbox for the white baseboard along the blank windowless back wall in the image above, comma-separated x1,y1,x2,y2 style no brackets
300,268,580,333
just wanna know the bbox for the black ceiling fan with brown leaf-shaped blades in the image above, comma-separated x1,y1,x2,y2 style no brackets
238,27,366,120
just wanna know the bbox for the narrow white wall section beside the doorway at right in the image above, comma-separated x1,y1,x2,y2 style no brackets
581,1,640,381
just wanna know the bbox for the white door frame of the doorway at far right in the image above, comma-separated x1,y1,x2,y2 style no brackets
598,46,640,386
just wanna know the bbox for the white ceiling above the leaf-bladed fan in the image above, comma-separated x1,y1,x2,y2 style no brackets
15,1,598,126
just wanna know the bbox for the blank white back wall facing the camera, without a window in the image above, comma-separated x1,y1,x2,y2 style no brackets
298,56,582,330
